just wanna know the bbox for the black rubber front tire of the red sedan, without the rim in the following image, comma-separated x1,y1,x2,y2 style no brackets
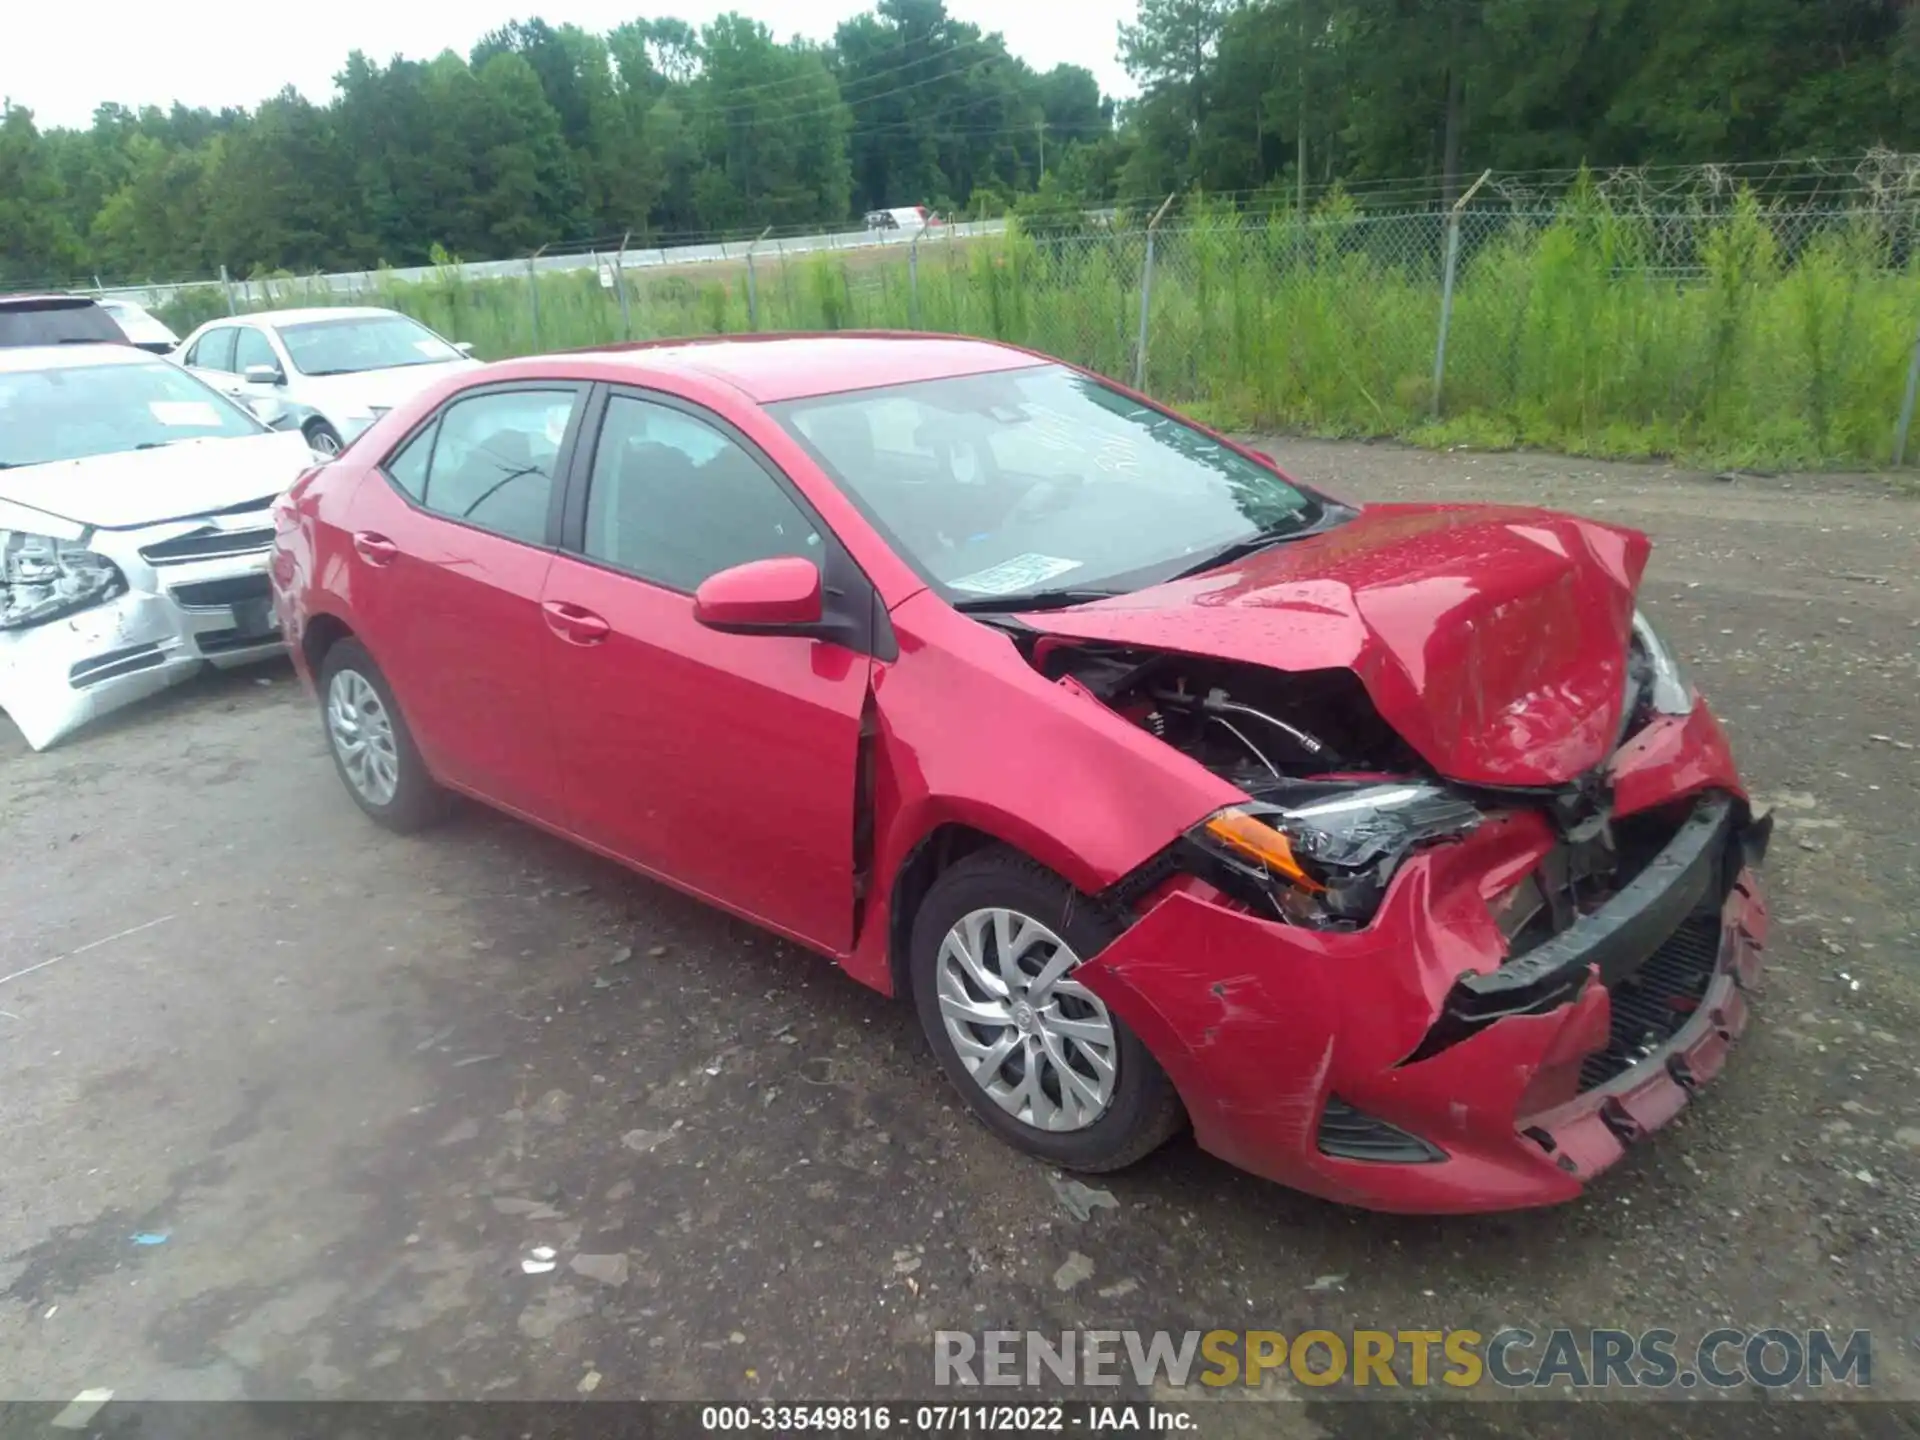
908,847,1187,1171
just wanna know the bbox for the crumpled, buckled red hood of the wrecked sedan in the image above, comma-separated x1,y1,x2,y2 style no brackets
1025,505,1649,785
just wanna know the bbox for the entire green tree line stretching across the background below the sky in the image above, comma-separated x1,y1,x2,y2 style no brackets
0,0,1920,282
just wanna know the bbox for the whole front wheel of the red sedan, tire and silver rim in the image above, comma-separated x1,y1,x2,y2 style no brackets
908,849,1183,1171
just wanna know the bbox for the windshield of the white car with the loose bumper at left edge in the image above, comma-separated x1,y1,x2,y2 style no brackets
0,361,265,467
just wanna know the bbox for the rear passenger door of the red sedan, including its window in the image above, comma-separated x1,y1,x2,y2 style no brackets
348,382,584,824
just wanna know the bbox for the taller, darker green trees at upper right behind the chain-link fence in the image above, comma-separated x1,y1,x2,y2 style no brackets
1121,0,1920,207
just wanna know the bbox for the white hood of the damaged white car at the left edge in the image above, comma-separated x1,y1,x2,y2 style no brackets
0,432,313,530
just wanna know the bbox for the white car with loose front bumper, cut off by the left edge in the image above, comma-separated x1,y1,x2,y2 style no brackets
0,344,321,751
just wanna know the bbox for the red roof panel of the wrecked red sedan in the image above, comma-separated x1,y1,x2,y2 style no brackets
568,332,1048,405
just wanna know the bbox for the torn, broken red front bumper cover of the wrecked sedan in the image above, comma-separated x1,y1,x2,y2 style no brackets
1077,707,1766,1213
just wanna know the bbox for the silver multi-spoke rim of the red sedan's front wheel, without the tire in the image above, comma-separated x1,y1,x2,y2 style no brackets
935,908,1119,1133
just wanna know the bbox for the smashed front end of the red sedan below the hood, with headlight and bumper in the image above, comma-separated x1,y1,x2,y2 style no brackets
1029,618,1768,1212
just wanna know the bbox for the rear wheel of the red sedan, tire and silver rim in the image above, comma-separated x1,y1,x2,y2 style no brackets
321,639,447,833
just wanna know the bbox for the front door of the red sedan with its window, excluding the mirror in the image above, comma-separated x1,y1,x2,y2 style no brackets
543,390,872,952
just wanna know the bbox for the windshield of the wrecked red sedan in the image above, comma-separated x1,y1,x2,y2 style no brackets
772,365,1319,605
